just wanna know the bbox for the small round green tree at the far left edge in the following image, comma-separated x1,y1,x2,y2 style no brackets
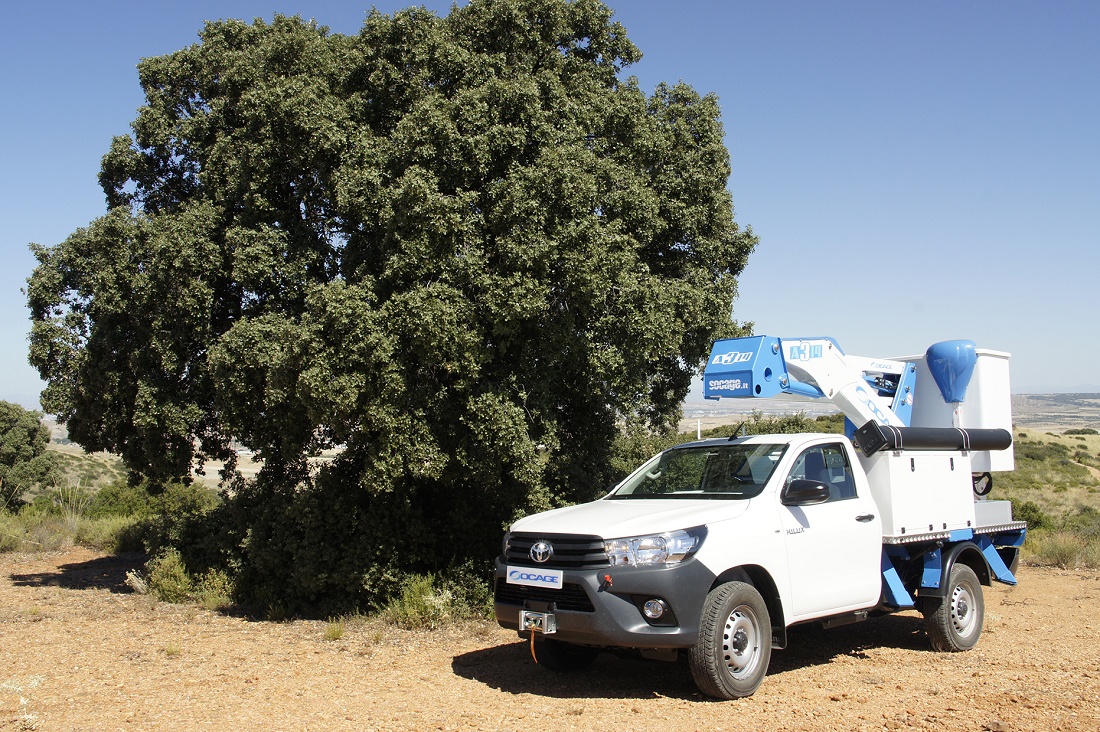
0,402,61,510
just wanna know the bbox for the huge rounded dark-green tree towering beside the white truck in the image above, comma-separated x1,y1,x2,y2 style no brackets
28,0,756,612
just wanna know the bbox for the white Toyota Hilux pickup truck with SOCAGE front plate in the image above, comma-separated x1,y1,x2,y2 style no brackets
495,338,1026,699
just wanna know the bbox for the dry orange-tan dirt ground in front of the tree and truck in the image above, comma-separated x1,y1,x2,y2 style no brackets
0,548,1100,732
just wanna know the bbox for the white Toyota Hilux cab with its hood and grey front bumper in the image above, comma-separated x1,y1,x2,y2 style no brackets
495,434,882,695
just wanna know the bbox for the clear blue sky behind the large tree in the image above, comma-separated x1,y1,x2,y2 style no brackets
0,0,1100,406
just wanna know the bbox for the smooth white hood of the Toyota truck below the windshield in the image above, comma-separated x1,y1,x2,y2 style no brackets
512,499,751,539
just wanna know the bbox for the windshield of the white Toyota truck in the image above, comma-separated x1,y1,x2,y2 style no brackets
608,443,787,500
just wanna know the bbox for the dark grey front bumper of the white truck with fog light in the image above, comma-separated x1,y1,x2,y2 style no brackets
493,557,714,648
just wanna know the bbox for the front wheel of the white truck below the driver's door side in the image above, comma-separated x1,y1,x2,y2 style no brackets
688,582,771,699
